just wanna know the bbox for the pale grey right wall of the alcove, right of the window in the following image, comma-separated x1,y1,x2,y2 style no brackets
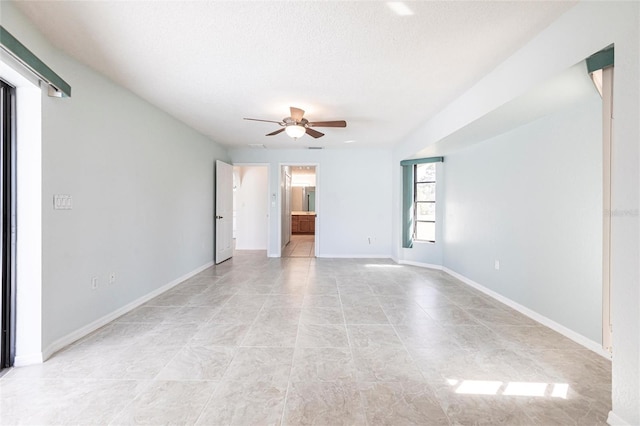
444,98,602,343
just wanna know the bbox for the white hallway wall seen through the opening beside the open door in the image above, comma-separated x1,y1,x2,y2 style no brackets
234,166,269,250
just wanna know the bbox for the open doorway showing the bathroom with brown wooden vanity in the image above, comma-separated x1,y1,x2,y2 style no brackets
282,165,318,257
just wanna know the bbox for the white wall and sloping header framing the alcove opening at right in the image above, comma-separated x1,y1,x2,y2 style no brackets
392,1,640,424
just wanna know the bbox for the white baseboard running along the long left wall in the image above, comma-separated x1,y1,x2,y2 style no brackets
38,262,213,366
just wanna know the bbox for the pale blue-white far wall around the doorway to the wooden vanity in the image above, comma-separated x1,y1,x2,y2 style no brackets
229,148,392,257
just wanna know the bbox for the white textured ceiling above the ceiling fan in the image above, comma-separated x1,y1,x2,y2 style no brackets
16,1,575,148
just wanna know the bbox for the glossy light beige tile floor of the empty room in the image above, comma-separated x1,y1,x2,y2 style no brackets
0,252,611,425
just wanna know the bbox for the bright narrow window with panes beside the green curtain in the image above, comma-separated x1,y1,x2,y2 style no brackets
413,163,436,243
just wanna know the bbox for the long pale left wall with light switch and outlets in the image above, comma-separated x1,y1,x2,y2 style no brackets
2,2,227,354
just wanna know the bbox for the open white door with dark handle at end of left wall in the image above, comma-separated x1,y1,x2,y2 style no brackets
215,160,233,265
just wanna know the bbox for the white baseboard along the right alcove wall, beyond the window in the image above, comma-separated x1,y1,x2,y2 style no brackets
442,267,611,360
